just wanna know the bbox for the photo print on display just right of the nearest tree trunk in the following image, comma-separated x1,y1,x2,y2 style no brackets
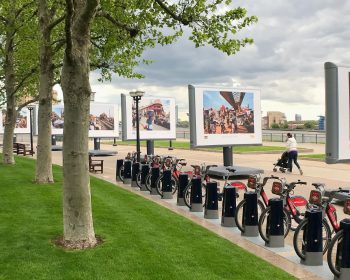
89,105,114,130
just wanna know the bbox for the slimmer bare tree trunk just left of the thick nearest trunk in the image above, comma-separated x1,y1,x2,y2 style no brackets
35,0,54,184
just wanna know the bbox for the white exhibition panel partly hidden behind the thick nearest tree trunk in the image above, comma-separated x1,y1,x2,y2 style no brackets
51,103,119,137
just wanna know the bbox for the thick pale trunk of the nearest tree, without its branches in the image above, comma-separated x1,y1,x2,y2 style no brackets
62,0,98,248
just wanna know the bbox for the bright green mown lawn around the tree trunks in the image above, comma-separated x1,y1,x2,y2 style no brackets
0,157,294,280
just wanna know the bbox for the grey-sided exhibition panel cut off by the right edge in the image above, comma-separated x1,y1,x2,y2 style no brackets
324,62,350,163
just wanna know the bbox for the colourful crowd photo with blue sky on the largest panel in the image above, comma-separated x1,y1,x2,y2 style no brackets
203,91,254,134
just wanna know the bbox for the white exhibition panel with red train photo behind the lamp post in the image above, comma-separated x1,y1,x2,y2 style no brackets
121,94,176,140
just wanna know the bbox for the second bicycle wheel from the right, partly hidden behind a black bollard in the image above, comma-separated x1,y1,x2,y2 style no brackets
293,219,331,260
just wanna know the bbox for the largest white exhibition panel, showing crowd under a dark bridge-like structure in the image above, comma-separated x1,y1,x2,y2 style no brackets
188,85,262,147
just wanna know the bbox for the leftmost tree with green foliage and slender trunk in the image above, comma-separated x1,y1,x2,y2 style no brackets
0,0,38,164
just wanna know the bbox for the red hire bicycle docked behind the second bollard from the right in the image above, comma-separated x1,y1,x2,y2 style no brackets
293,183,341,259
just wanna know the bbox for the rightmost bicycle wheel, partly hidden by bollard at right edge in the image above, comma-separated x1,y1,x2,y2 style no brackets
327,230,343,277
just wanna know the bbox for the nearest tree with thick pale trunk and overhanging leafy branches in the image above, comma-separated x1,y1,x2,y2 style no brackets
62,0,257,248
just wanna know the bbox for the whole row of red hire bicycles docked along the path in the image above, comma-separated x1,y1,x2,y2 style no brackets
118,154,350,276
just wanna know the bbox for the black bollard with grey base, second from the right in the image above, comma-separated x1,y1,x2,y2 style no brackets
300,209,323,266
